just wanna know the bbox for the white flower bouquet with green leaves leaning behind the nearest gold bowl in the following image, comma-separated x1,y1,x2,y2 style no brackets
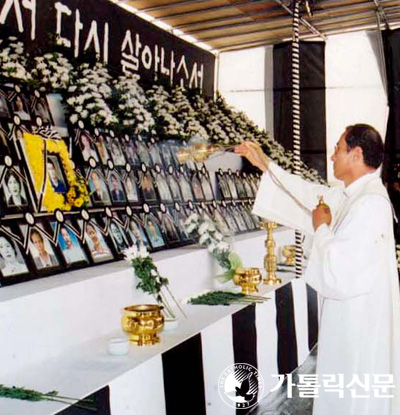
124,245,185,318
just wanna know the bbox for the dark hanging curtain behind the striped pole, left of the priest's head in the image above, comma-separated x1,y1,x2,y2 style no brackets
273,42,327,179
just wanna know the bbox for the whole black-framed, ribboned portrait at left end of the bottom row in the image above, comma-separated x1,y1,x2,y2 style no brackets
0,226,30,286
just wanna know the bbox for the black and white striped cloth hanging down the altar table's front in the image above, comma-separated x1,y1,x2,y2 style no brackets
59,279,318,415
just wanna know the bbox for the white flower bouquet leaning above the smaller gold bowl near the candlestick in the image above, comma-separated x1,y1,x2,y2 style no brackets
185,213,242,282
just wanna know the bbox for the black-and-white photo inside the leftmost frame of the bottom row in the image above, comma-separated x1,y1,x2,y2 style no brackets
0,231,29,279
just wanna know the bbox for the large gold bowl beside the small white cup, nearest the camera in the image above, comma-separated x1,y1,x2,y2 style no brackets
122,304,164,346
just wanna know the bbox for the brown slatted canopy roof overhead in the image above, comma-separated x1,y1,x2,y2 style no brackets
120,0,400,52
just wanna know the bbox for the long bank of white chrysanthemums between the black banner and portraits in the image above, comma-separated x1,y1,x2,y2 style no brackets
0,31,323,182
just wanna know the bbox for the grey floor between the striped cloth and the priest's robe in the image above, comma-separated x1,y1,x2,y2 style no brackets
250,346,317,415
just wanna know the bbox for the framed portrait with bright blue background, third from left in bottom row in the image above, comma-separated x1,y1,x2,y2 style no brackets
51,221,89,266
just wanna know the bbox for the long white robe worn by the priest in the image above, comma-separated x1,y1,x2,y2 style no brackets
253,163,400,415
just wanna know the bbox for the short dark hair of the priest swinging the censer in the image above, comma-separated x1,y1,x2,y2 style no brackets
345,124,384,169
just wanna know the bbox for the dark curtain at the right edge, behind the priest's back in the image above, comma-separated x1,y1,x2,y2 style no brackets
383,30,400,243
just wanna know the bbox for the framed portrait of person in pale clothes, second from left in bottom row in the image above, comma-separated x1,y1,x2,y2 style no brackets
20,223,61,274
